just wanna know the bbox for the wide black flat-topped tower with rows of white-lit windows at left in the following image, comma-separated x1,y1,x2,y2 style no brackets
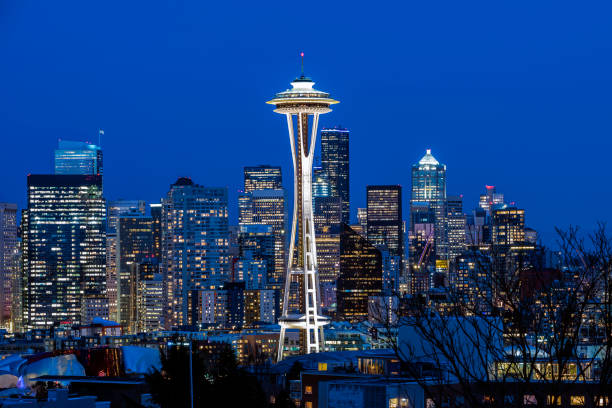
22,175,108,329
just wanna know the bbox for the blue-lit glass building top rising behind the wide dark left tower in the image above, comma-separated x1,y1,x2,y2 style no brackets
55,140,103,175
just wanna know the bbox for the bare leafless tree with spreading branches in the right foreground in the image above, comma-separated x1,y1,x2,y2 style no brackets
375,225,612,407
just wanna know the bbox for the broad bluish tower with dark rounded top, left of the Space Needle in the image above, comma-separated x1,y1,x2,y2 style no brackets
162,177,229,327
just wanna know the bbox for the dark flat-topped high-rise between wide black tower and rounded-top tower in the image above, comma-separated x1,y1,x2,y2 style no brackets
116,214,156,333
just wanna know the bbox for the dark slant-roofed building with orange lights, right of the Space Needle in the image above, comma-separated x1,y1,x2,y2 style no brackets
337,224,383,321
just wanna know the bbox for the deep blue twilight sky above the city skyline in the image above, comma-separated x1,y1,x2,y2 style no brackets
0,0,612,242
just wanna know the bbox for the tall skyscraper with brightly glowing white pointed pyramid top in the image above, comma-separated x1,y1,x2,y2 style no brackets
410,149,448,260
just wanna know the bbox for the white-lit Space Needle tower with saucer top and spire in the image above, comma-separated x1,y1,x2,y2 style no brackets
267,53,338,361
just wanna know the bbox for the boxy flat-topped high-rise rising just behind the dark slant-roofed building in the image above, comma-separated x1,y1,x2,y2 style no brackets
366,186,404,270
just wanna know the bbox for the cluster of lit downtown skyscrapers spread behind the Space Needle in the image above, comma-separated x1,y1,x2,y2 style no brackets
2,131,536,338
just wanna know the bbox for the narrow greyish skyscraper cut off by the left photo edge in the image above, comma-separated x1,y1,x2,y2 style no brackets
0,203,19,328
